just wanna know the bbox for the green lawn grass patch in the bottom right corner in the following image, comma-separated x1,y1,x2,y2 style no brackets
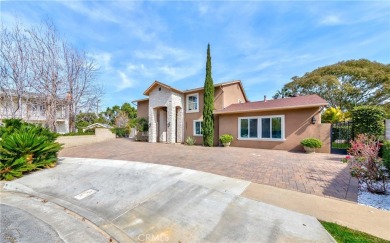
320,221,390,243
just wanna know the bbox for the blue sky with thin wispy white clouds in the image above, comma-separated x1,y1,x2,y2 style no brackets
0,1,390,109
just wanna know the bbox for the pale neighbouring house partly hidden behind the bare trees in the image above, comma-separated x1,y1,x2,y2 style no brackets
0,92,69,133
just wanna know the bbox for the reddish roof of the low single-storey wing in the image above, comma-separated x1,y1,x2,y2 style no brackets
214,95,328,114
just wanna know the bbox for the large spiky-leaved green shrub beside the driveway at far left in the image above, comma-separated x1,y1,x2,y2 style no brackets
0,121,61,180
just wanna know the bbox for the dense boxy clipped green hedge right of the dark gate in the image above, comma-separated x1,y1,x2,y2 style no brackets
352,106,385,137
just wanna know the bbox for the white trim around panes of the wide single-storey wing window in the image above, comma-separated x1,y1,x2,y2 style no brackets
237,115,286,142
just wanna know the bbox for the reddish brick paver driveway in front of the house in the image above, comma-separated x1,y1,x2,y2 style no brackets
60,139,358,202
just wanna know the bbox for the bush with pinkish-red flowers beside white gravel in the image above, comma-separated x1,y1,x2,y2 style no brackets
342,134,389,193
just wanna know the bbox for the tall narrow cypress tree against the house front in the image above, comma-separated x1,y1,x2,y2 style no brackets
202,44,214,147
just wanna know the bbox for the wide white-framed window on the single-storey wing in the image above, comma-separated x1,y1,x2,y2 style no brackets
238,115,285,141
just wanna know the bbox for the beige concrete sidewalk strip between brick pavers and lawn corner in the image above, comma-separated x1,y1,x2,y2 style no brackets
241,183,390,240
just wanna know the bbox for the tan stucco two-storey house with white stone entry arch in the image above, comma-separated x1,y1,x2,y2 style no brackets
133,80,330,152
